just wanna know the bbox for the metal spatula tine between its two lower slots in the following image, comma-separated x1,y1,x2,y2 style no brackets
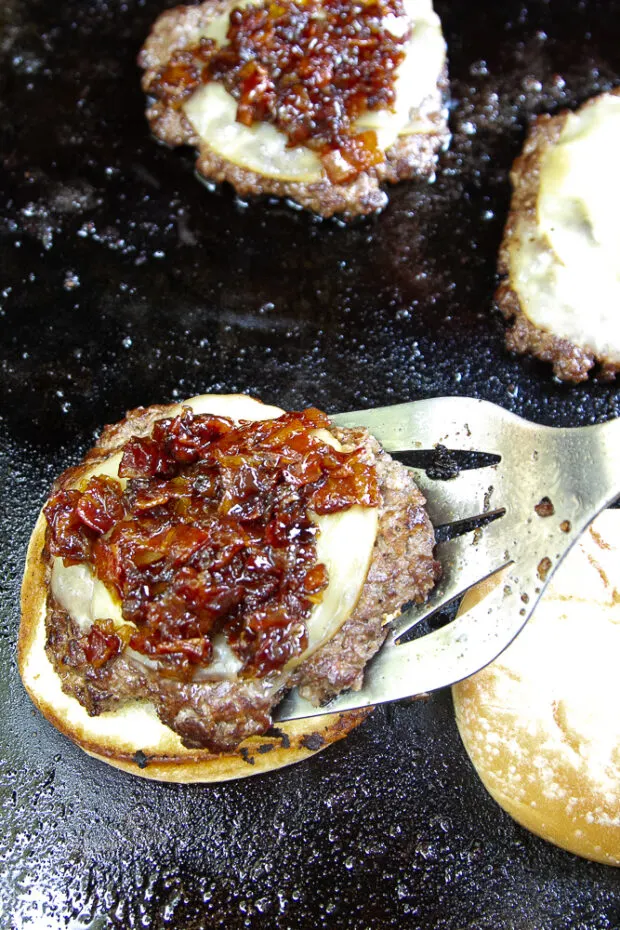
390,518,510,639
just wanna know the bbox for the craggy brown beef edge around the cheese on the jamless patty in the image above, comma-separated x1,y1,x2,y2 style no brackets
495,91,620,382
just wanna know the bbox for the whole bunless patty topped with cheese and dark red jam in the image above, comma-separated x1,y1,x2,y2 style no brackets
139,0,449,216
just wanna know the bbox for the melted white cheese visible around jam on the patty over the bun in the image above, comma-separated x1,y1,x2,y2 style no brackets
51,394,379,680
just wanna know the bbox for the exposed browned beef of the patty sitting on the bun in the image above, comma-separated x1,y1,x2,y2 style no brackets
29,398,439,753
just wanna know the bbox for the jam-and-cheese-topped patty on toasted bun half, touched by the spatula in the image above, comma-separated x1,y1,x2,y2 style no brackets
20,395,439,774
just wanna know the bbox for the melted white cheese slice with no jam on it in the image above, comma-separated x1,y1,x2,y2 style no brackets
511,94,620,362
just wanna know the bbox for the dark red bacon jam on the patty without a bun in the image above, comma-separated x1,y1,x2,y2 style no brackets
151,0,411,182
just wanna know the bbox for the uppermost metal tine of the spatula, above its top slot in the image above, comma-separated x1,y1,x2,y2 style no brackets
330,397,518,452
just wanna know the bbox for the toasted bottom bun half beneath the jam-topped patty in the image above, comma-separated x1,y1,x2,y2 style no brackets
18,397,372,782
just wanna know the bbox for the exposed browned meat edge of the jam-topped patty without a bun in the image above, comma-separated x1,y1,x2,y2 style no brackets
139,0,449,217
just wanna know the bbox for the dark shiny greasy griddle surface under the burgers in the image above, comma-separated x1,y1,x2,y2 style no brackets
0,0,620,930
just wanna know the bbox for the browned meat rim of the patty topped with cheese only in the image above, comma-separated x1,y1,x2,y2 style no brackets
495,92,620,382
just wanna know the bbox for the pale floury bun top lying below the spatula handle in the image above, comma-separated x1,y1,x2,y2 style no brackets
453,510,620,865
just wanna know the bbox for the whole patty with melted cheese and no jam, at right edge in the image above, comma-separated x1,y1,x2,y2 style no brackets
496,91,620,381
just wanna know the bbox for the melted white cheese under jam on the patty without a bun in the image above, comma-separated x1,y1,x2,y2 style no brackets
184,0,446,184
